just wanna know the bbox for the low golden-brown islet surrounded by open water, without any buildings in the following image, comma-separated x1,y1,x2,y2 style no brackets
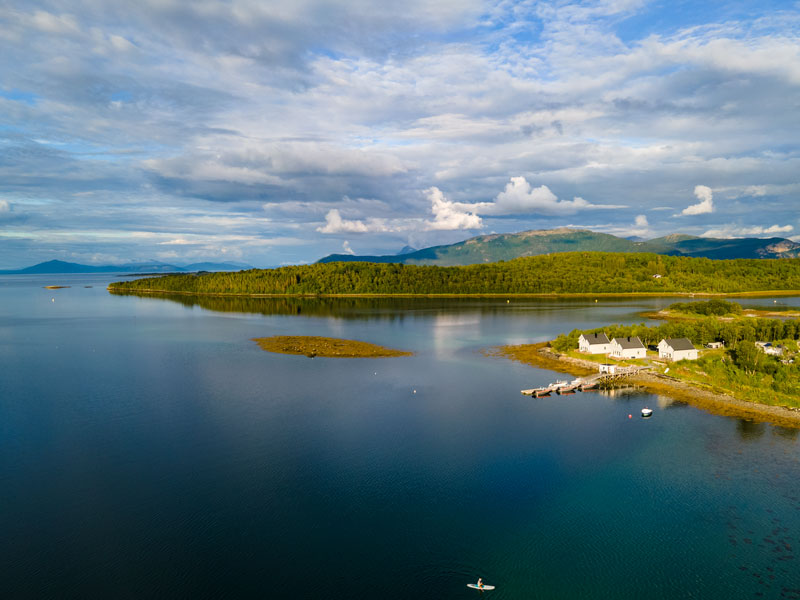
253,335,414,358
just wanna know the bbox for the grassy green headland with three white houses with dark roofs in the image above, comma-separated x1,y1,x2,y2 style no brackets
493,299,800,427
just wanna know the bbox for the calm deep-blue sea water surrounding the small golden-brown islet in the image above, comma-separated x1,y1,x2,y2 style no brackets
0,276,800,600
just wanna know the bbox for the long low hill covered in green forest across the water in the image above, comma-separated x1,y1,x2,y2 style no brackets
109,252,800,295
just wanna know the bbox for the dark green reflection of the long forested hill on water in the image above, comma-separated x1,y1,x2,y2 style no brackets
112,291,544,321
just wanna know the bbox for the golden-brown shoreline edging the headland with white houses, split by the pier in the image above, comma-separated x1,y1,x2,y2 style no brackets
488,342,800,428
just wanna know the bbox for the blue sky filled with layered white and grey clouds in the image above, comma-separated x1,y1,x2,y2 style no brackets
0,0,800,269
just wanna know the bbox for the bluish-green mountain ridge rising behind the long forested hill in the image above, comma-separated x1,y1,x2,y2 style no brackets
318,227,800,266
